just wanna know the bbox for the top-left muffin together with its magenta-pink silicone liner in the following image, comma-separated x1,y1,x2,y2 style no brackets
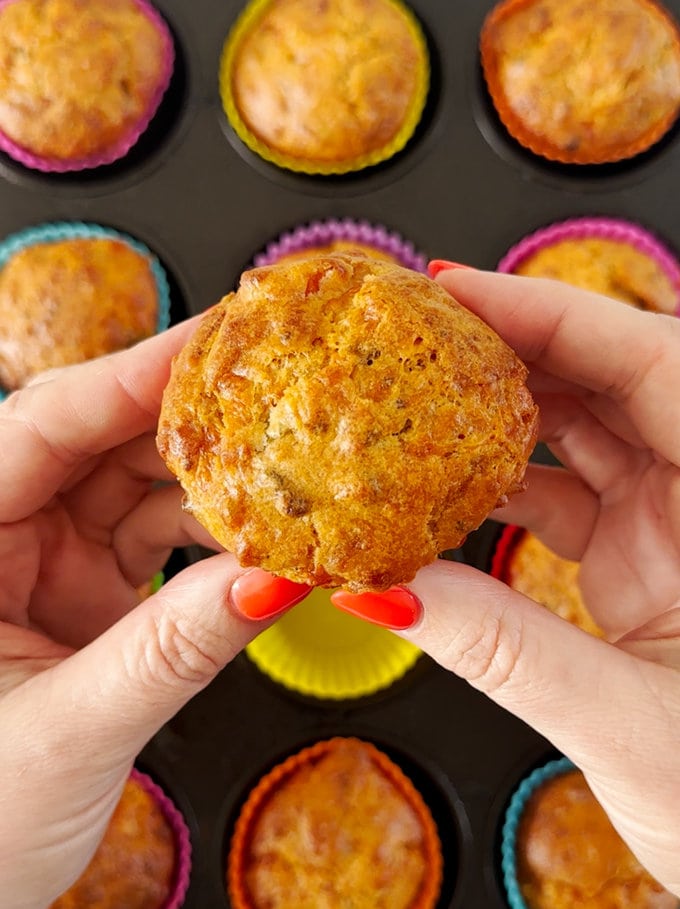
0,0,175,173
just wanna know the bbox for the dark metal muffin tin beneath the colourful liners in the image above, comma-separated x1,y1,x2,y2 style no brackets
5,0,680,909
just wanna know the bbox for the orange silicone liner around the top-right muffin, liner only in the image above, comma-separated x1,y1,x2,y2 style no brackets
479,0,680,165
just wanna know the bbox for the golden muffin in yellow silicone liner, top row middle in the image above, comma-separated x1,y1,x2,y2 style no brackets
220,0,429,174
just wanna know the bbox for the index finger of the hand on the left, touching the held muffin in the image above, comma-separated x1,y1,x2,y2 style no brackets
0,316,206,522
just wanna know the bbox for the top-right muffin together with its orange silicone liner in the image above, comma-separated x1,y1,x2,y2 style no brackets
480,0,680,164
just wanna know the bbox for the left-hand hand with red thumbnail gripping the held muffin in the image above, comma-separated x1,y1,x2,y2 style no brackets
0,319,309,909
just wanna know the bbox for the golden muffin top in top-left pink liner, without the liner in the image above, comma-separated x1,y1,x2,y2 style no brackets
0,0,165,160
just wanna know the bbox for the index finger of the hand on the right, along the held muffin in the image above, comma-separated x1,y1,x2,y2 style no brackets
437,269,680,464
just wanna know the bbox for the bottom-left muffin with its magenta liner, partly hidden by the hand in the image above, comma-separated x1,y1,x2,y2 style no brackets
50,768,191,909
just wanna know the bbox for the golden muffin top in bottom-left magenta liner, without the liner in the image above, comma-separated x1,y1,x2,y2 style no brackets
50,779,176,909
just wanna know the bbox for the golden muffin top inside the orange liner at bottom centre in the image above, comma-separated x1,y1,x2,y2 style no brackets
244,739,436,909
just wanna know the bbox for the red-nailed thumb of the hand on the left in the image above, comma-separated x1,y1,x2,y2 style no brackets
18,553,310,769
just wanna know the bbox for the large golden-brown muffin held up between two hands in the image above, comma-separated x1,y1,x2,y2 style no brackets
158,254,537,591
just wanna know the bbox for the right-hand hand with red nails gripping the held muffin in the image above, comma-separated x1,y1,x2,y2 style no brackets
333,270,680,896
